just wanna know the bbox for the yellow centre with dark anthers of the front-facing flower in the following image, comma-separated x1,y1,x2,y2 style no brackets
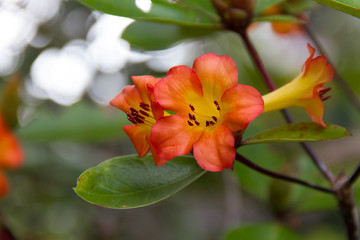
187,100,221,127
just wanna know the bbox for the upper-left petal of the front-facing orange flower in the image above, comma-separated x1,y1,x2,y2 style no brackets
154,66,203,115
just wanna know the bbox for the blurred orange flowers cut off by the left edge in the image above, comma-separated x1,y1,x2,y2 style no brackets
0,115,23,198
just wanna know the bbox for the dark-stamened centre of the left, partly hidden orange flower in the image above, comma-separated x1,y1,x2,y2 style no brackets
126,102,155,127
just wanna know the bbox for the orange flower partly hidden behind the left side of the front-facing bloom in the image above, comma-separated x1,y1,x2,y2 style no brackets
110,76,166,166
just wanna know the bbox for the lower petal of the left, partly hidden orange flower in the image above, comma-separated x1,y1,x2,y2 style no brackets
123,125,150,157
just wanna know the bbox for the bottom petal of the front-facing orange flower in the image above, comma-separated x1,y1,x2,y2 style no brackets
194,124,235,172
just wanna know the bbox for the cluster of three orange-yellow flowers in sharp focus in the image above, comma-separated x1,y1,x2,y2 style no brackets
110,46,332,171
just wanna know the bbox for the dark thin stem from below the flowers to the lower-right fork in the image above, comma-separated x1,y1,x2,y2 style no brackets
235,153,334,194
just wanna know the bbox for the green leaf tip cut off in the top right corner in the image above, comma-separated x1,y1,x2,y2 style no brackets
315,0,360,18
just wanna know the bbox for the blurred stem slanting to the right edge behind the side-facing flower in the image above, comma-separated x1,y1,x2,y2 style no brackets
304,24,360,111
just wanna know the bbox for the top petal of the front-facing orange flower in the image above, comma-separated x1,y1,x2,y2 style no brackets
193,53,238,101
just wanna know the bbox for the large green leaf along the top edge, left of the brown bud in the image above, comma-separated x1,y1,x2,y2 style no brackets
79,0,220,28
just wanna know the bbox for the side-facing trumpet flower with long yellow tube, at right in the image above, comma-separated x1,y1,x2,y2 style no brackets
263,44,333,128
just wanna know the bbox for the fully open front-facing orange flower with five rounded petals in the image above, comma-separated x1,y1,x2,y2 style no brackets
150,53,264,171
